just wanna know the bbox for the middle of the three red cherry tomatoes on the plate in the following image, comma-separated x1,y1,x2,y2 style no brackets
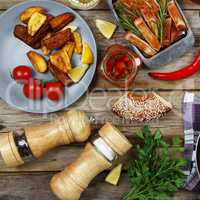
23,78,44,100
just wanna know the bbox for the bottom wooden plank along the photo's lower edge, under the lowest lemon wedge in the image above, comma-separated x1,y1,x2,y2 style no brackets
0,173,200,200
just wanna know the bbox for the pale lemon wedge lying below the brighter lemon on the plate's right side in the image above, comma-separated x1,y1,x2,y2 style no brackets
68,64,89,83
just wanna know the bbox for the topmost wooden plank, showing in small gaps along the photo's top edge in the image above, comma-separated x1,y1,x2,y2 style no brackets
0,0,200,10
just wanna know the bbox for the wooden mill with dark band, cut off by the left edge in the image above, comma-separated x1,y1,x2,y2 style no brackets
0,110,91,167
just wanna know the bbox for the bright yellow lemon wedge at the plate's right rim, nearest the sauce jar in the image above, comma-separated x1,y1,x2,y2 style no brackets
81,42,94,65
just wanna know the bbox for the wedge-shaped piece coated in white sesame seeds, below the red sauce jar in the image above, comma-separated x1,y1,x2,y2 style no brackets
112,92,172,122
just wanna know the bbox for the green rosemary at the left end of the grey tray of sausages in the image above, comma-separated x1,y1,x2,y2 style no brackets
114,2,141,36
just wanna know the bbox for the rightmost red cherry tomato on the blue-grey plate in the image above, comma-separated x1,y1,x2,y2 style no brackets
46,82,64,101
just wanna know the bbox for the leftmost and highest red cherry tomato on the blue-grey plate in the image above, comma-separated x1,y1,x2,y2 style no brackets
12,66,33,83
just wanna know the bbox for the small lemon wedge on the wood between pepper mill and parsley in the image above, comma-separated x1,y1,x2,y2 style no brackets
105,164,122,185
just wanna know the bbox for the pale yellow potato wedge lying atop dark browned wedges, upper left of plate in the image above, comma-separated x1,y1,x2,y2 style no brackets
28,12,47,36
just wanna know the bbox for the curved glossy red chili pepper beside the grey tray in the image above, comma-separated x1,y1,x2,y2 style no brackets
149,51,200,81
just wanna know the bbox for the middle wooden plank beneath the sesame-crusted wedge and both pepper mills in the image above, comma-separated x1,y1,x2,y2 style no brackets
0,91,192,172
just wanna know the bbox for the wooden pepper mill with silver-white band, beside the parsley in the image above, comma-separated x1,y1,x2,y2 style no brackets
51,123,132,200
